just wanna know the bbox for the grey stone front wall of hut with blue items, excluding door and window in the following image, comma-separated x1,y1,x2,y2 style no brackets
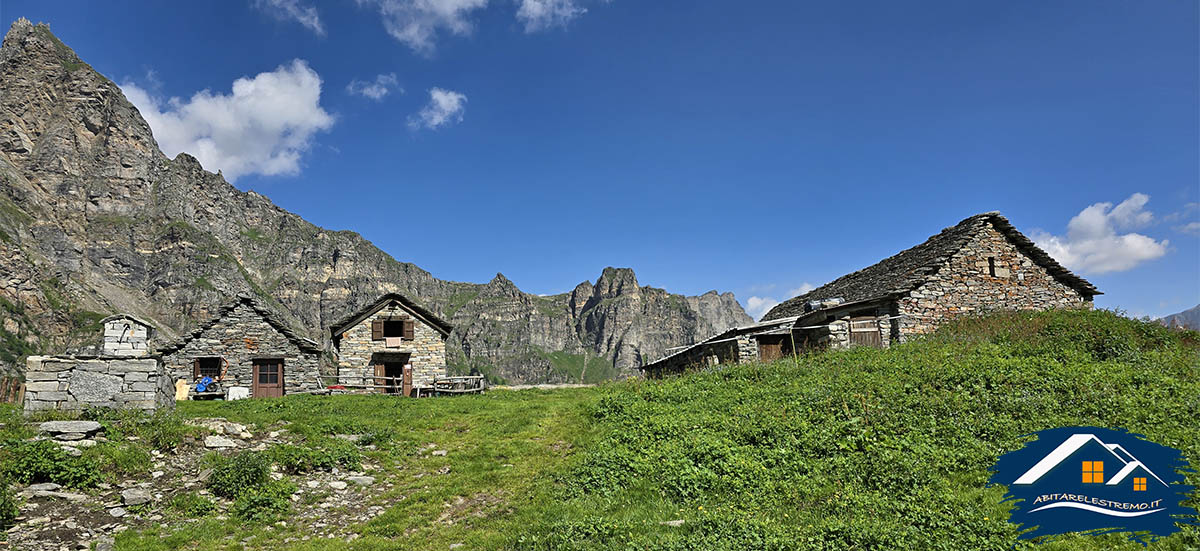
163,303,325,394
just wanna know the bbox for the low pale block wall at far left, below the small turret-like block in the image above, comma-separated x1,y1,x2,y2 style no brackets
25,355,175,413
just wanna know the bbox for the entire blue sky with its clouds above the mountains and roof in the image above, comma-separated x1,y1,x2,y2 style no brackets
0,0,1200,316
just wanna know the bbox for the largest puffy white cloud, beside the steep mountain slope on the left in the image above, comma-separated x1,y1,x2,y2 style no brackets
121,59,334,181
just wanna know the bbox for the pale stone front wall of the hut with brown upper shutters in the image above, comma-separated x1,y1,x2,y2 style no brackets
335,303,446,387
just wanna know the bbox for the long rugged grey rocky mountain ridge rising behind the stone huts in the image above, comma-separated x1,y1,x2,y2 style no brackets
0,19,750,382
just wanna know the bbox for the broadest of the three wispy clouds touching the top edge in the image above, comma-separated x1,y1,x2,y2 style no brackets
358,0,487,54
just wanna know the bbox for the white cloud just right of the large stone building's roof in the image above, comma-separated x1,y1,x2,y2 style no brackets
1033,193,1169,274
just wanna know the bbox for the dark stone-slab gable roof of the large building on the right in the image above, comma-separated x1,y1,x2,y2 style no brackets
763,212,1103,319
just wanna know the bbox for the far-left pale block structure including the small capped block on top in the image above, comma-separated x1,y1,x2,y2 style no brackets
24,315,175,413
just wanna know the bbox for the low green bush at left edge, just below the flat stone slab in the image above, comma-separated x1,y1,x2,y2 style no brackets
2,441,101,487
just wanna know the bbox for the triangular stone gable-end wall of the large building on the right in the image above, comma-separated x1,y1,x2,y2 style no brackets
896,223,1092,340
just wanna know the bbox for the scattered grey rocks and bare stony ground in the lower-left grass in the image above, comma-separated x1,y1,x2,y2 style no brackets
0,419,415,551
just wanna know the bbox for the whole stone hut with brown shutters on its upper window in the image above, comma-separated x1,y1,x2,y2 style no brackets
330,293,454,393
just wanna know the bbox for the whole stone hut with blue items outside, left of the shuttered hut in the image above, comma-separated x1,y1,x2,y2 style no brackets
160,295,325,399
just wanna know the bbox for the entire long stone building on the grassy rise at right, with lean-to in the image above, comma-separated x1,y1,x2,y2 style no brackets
642,212,1102,377
